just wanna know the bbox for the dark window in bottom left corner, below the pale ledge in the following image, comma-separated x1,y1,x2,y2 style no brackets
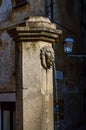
1,102,16,130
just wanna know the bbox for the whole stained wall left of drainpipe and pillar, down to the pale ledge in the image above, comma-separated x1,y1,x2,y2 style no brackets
0,0,45,92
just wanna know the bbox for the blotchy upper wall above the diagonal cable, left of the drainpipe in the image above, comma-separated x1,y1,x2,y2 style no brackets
0,0,45,30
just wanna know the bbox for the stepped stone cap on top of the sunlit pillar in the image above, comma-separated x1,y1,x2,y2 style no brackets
8,16,62,43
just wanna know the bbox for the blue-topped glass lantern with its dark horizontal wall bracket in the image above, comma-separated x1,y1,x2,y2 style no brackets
64,36,86,58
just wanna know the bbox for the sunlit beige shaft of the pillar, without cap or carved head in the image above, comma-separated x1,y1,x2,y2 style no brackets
22,42,53,130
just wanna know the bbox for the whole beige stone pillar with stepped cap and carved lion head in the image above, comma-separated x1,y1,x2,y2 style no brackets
7,16,61,130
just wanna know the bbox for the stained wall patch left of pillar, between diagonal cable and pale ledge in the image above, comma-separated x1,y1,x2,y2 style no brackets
0,31,15,91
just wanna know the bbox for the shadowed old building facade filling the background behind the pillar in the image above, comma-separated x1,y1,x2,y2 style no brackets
0,0,86,130
